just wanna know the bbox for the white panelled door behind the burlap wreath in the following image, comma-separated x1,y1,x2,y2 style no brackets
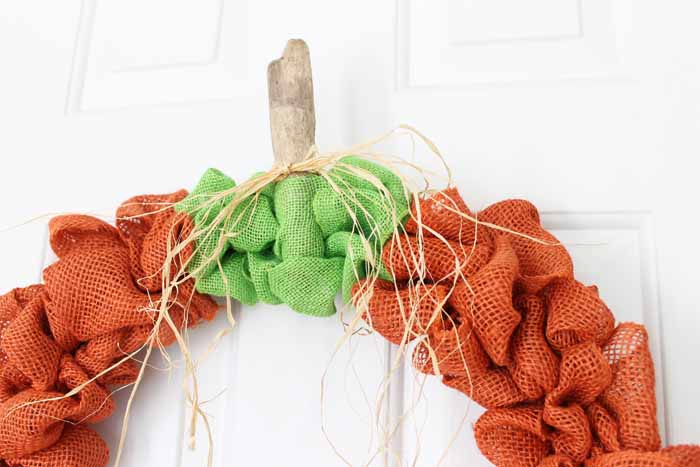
0,0,700,467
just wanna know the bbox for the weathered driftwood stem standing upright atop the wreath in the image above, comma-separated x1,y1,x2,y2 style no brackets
267,39,316,165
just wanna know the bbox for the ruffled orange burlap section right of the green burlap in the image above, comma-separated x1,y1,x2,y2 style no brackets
355,189,700,467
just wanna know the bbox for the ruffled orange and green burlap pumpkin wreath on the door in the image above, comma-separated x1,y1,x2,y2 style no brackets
0,164,700,467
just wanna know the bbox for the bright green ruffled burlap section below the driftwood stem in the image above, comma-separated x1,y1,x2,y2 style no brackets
175,156,409,316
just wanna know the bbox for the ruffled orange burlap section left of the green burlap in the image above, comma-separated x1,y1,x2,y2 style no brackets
0,191,216,467
